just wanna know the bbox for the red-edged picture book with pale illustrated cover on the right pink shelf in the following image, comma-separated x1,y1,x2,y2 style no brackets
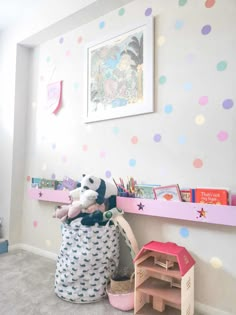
153,185,182,201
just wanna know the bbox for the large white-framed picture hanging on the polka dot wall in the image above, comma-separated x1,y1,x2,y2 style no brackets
84,18,154,122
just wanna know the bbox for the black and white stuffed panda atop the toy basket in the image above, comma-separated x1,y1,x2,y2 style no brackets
80,175,117,209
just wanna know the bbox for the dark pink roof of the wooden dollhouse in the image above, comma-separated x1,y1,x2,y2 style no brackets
134,241,195,276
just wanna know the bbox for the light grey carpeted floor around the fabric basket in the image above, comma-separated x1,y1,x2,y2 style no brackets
0,251,199,315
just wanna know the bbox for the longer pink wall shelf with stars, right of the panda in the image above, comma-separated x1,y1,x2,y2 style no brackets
117,197,236,226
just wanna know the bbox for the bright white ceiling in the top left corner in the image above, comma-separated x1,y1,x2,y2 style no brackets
0,0,45,31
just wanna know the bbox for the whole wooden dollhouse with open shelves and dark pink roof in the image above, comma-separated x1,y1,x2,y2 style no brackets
134,241,195,315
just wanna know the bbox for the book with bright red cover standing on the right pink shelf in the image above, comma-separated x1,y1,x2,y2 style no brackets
195,188,229,205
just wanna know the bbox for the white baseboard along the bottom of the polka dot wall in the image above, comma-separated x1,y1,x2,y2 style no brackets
8,243,233,315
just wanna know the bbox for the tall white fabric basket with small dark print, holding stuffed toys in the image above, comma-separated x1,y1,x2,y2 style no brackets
55,218,119,303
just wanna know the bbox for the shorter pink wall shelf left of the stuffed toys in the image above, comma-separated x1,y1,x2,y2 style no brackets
28,188,70,204
